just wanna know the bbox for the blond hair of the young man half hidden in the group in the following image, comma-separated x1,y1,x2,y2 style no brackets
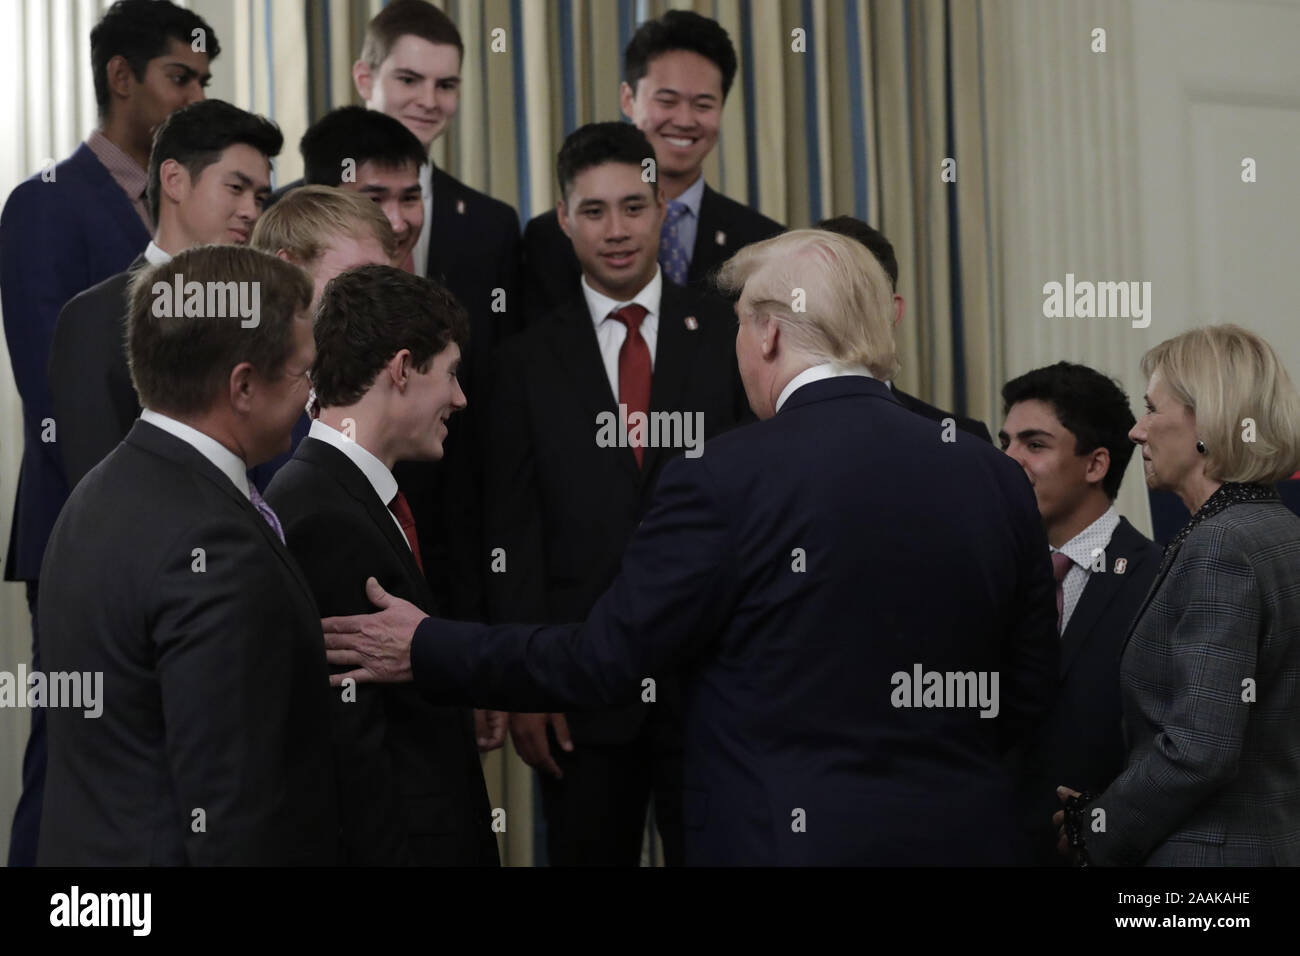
248,186,398,268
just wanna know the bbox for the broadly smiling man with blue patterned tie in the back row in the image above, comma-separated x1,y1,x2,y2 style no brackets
524,10,783,321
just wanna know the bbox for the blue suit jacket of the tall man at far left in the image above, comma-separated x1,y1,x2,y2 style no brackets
0,143,150,581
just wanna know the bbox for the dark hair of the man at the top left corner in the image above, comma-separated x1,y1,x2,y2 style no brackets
90,0,221,120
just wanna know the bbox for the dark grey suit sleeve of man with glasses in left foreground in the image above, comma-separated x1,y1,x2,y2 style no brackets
151,519,325,866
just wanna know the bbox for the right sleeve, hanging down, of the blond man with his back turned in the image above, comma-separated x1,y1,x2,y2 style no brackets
998,470,1061,750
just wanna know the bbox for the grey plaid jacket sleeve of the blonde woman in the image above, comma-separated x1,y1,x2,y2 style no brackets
1088,529,1262,866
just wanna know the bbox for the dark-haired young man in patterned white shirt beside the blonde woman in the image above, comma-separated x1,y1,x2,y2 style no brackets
997,362,1160,866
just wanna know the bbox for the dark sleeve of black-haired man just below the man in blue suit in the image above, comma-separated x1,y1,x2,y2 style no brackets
49,290,130,488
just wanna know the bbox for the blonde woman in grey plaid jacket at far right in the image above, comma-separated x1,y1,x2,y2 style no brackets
1056,325,1300,866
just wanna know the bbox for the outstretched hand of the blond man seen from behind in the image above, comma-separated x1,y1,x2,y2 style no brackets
321,578,429,687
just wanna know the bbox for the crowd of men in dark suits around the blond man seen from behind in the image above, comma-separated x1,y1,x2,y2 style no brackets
0,0,1154,865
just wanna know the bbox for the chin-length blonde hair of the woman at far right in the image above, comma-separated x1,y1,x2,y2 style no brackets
1141,325,1300,485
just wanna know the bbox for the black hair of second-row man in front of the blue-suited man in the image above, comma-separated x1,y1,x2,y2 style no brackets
148,100,285,222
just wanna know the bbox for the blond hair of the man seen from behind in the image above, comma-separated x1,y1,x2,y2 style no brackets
716,229,898,381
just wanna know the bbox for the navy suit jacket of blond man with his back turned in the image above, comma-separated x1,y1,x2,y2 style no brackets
411,377,1058,865
